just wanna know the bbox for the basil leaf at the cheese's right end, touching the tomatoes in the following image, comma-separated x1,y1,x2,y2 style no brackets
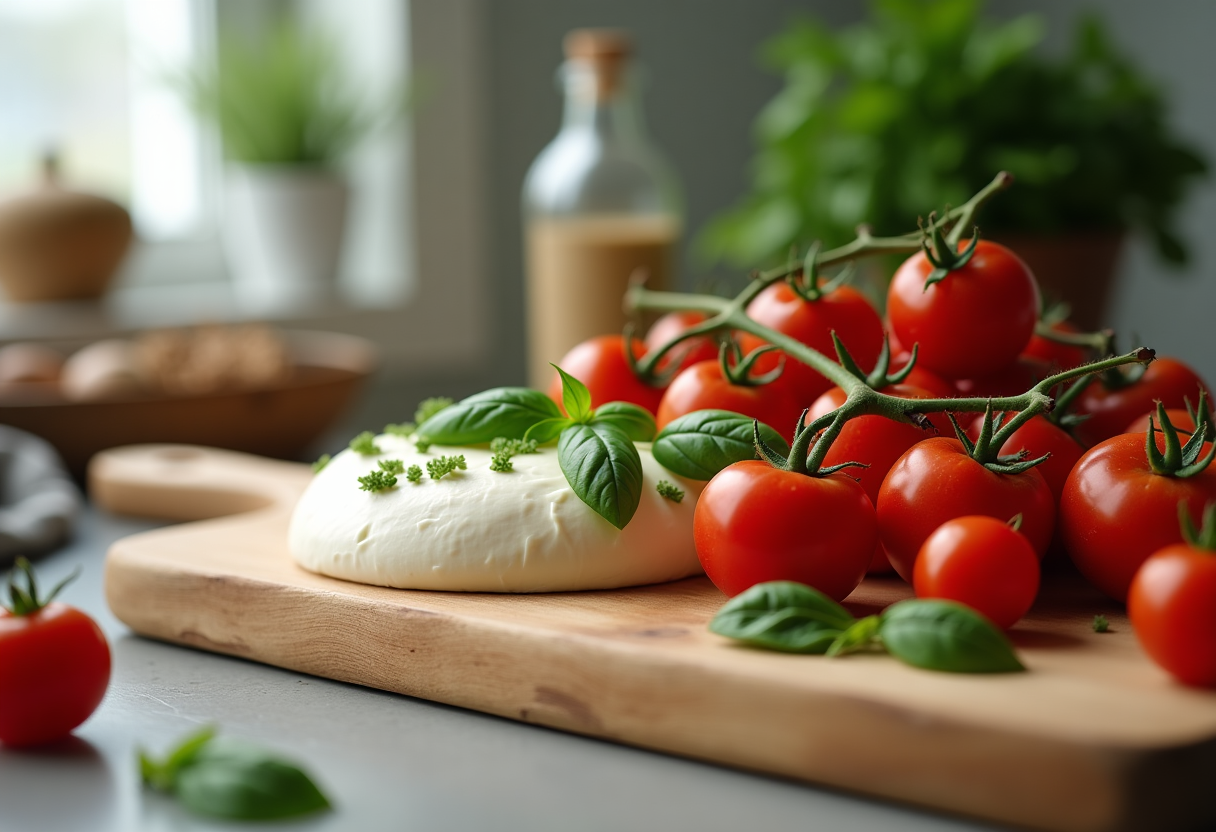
653,410,789,480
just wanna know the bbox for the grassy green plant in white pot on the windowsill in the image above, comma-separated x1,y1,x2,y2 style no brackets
180,17,406,307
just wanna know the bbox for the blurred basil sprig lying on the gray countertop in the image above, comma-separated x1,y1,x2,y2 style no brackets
139,727,330,820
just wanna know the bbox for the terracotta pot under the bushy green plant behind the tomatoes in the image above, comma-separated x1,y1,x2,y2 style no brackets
992,230,1125,332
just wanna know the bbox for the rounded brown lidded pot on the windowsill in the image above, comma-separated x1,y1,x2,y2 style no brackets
0,157,133,303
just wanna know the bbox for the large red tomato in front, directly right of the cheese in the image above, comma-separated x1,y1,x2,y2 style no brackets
693,460,878,601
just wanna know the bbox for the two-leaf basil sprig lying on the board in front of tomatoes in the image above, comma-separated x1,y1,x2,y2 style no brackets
709,581,1025,673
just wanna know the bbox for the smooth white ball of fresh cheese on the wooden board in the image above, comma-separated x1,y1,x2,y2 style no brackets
288,435,704,592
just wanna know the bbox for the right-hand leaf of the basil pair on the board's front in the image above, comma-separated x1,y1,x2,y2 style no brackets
878,598,1026,673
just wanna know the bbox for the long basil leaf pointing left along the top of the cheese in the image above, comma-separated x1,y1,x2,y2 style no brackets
417,387,562,445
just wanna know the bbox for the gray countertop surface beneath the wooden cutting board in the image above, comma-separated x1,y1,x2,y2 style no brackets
0,510,992,832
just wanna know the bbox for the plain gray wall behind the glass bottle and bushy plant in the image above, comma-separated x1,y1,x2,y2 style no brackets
342,0,1216,437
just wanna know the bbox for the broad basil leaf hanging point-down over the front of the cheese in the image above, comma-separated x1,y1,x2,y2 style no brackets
557,425,642,529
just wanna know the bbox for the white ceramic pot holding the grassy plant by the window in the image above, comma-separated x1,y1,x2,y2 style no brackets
221,165,350,310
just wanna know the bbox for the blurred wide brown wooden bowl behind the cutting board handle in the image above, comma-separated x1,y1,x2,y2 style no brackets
0,332,376,477
